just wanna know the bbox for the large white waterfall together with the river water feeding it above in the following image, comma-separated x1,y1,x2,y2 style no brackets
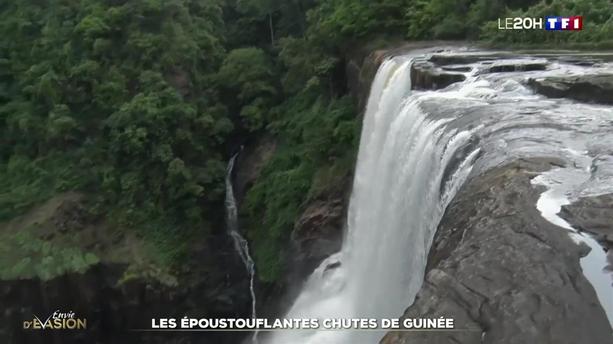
269,49,613,344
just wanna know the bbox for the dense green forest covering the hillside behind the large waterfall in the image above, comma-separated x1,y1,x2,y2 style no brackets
0,0,613,281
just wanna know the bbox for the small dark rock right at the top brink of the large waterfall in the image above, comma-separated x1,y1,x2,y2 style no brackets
411,61,466,90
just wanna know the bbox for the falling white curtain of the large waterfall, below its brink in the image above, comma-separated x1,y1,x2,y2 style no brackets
270,57,478,344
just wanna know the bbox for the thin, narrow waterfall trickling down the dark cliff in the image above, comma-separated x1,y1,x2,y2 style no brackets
226,152,258,344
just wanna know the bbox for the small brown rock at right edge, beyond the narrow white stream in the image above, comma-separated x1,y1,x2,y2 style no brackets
560,194,613,246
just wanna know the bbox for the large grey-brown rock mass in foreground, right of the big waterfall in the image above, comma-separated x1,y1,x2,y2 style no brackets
381,160,613,344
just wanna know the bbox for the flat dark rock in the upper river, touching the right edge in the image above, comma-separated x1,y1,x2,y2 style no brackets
528,74,613,104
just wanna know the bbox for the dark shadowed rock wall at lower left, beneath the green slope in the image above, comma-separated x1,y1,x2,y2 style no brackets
0,236,250,344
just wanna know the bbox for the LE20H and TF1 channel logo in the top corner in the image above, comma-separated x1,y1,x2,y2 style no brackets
498,16,583,31
